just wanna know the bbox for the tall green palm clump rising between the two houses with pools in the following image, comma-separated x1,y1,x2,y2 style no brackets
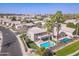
45,11,64,39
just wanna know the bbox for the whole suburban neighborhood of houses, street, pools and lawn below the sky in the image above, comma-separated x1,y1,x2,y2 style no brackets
0,3,79,56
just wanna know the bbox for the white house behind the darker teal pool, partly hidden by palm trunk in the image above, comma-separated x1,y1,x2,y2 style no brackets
54,24,75,36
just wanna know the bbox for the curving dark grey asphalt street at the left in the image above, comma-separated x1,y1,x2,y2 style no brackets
0,26,22,56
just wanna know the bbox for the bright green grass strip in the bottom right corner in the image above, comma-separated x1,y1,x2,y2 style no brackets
56,41,79,56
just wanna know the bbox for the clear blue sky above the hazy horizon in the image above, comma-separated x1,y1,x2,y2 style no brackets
0,3,79,14
